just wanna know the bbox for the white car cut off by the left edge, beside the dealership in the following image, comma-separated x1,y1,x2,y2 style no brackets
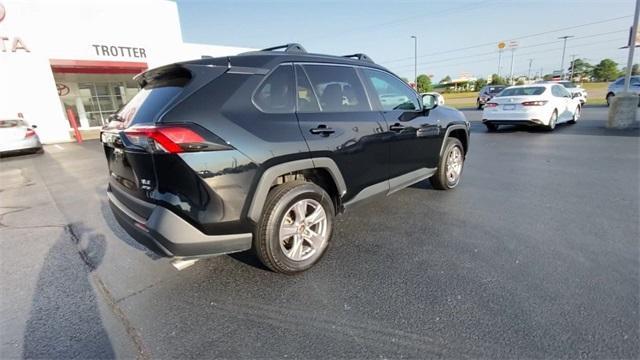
0,118,42,155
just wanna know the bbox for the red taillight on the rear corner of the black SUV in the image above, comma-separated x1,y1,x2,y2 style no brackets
124,125,231,154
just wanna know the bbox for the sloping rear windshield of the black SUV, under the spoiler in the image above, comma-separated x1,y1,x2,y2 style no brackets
116,70,191,127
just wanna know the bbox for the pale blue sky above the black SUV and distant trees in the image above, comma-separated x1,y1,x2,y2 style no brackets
176,0,637,81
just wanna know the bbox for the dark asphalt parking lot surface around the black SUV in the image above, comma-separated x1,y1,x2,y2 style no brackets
0,107,640,359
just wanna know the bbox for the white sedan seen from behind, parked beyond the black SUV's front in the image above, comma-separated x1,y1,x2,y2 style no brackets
482,84,582,131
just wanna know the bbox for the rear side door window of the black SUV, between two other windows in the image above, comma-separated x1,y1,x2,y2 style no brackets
303,65,371,112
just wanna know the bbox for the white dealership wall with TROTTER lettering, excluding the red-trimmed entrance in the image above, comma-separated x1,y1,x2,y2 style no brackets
0,0,255,143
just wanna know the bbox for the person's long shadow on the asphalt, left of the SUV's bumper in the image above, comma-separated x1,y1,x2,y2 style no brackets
23,224,116,359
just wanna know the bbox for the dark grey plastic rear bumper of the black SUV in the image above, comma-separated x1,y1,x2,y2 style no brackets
107,191,252,257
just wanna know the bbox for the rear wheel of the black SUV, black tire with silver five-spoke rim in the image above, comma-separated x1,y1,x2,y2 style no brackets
253,181,335,275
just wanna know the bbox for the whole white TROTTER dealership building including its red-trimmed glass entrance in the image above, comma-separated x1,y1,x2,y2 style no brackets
0,0,250,143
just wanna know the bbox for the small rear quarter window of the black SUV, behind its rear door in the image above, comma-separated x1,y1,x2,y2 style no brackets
253,64,295,114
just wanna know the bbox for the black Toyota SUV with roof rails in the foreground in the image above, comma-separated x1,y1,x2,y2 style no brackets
101,44,469,273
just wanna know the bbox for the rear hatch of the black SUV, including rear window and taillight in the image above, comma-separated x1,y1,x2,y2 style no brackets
101,64,226,218
